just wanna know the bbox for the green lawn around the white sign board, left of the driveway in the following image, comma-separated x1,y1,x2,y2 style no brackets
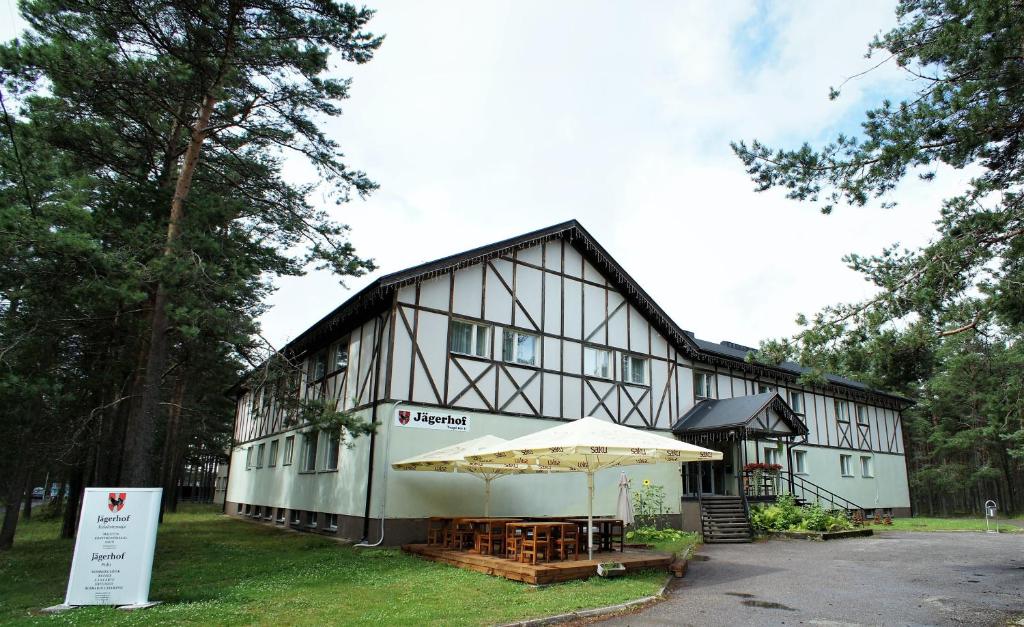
0,508,666,625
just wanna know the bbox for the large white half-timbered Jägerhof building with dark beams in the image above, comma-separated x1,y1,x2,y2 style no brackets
225,220,909,544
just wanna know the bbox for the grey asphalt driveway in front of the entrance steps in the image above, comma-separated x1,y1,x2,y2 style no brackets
602,532,1024,625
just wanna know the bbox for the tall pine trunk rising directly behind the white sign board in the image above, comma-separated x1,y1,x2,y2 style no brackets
124,91,219,487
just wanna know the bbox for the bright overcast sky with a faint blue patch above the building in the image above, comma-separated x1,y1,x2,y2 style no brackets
0,0,965,345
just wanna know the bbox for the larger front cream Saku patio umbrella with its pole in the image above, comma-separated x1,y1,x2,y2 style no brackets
465,417,722,559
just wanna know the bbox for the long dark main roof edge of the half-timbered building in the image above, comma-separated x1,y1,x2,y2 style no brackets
256,219,912,406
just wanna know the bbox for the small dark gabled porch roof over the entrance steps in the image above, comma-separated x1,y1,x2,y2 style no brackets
672,391,808,435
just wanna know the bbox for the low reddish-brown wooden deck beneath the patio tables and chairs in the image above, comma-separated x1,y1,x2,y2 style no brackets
401,544,672,585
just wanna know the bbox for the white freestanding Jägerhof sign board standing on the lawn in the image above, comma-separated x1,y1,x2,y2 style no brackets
65,488,163,605
